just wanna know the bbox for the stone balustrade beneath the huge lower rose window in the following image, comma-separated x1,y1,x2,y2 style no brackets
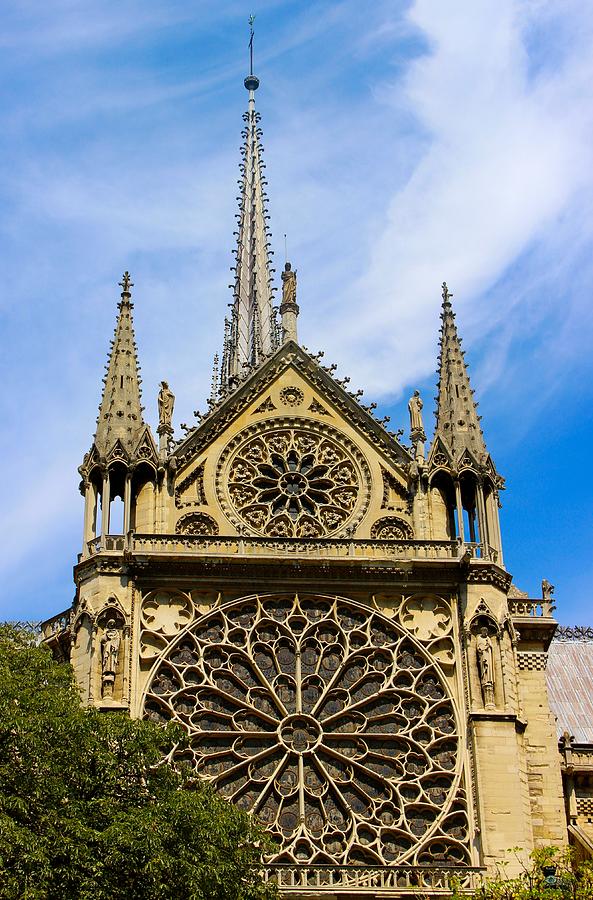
264,864,484,897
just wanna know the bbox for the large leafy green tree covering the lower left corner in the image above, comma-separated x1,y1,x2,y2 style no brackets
0,626,275,900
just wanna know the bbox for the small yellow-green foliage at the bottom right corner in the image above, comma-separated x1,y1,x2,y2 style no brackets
453,847,593,900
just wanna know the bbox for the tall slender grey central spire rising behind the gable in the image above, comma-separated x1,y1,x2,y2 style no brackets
220,16,279,394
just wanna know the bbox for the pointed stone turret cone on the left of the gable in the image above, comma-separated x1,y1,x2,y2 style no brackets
95,272,144,457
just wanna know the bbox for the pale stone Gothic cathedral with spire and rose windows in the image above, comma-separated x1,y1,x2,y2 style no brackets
44,59,593,898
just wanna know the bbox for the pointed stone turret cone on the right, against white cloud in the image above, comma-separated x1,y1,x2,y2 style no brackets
433,283,488,464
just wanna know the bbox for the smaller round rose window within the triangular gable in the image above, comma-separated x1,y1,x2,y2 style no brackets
218,419,371,538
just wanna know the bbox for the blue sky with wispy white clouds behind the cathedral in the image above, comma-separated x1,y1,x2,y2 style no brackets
0,0,593,623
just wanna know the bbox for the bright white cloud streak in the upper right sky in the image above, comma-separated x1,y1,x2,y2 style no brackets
330,0,593,394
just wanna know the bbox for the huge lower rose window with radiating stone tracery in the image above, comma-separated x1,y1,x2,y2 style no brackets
144,595,469,865
